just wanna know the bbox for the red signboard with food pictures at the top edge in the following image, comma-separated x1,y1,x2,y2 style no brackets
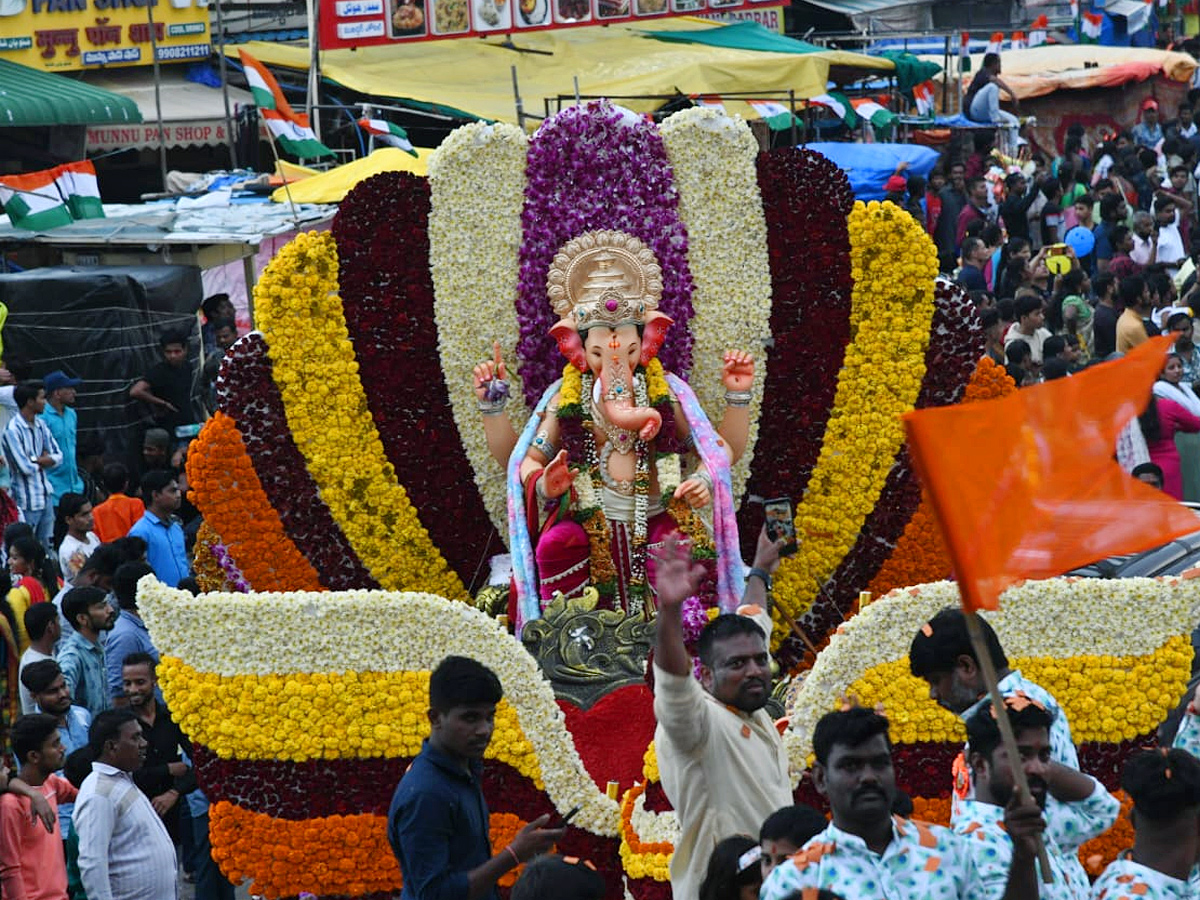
318,0,779,50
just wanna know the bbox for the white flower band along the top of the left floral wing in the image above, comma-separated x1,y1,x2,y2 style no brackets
138,576,620,836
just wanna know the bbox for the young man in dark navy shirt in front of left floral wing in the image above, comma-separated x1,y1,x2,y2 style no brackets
388,656,566,900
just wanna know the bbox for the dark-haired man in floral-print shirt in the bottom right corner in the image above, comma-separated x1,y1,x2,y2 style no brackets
1092,748,1200,900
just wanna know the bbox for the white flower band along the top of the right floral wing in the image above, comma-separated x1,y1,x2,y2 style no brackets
784,578,1200,778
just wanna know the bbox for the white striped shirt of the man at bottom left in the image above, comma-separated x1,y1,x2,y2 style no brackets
74,762,178,900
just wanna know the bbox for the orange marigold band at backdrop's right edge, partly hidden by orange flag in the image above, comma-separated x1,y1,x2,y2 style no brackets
869,356,1016,596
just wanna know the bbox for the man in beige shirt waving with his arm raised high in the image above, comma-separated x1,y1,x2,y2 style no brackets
654,541,792,900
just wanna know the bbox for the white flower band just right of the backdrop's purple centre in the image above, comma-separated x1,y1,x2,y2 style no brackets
659,107,772,503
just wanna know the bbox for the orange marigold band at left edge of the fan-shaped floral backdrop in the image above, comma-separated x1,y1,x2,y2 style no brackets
187,412,323,590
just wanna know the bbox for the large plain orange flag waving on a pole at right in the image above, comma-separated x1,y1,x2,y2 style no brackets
905,336,1198,610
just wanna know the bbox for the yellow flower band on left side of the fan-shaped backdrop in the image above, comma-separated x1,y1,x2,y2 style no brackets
254,232,469,601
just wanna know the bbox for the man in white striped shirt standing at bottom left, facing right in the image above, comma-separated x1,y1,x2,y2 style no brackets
74,708,178,900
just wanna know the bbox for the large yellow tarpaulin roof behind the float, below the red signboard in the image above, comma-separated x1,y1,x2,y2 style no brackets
229,19,864,122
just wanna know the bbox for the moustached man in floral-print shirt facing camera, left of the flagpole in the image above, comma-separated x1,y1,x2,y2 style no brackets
760,708,1042,900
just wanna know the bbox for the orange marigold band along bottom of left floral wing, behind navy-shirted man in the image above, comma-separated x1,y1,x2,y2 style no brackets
209,802,526,900
